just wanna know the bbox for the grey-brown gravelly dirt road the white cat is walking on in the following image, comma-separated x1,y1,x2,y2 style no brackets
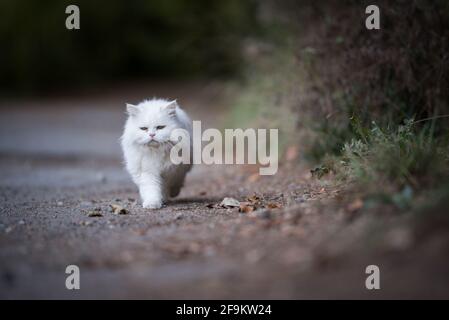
0,83,449,299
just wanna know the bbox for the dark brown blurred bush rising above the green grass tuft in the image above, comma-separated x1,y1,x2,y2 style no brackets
290,0,449,161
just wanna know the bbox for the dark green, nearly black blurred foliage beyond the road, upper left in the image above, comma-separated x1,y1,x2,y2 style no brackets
0,0,257,92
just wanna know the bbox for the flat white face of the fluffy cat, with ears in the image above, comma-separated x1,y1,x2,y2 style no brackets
127,100,178,147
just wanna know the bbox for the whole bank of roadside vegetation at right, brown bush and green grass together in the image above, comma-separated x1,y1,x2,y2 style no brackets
228,0,449,209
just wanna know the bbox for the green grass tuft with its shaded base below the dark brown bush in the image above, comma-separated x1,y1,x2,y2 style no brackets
326,119,449,209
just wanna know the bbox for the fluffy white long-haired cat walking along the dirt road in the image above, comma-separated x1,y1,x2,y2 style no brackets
121,99,192,209
